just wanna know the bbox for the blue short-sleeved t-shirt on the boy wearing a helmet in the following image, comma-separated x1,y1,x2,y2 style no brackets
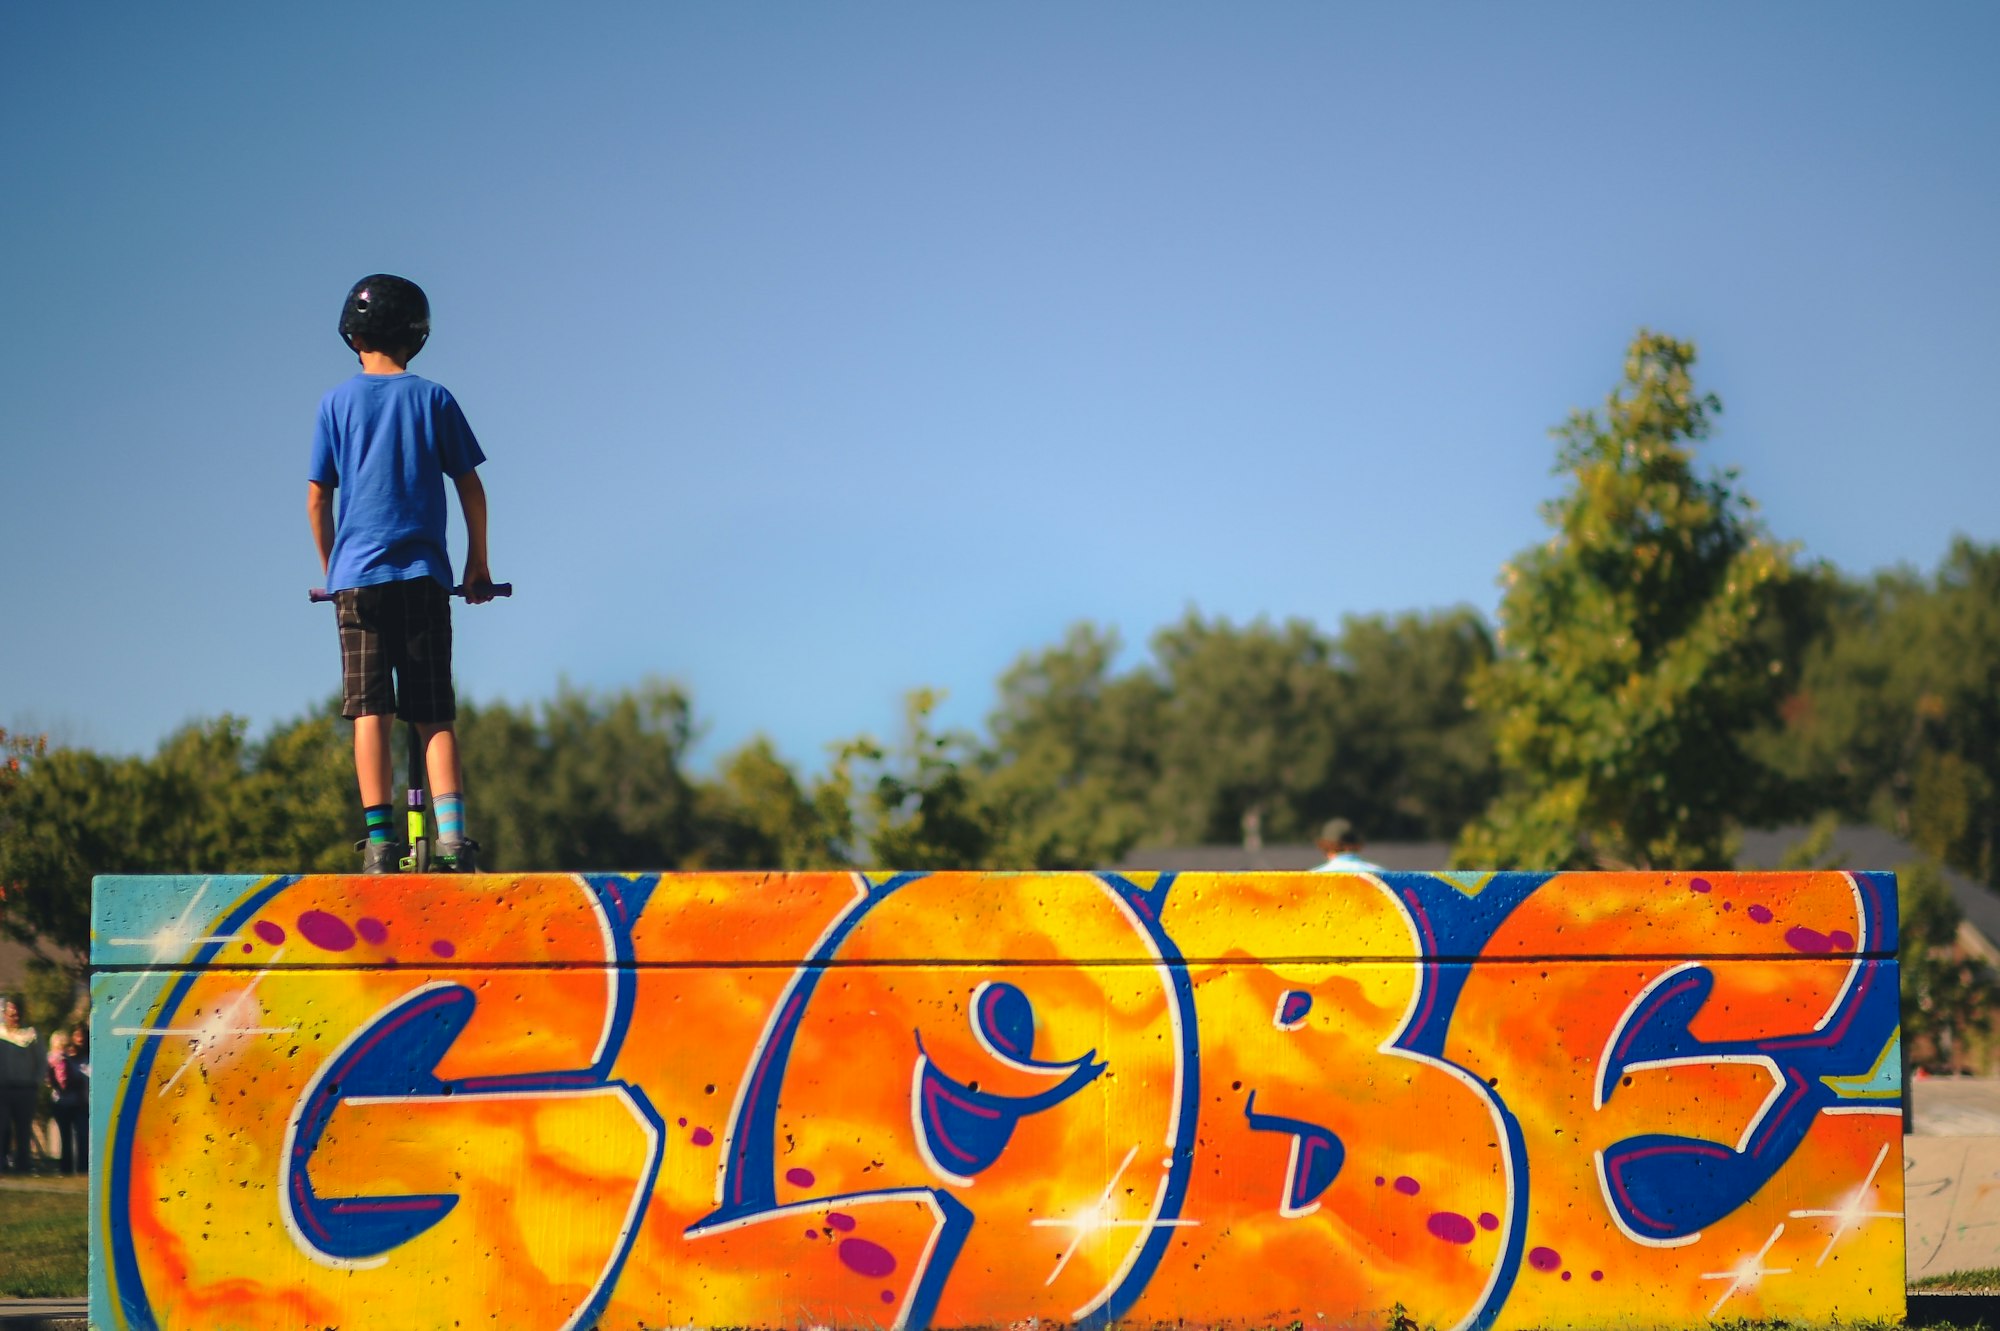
310,374,486,592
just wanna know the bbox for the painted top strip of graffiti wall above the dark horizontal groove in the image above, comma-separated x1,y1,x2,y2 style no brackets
90,871,1896,969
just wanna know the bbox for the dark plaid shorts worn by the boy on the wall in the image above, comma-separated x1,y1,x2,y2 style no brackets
334,578,458,721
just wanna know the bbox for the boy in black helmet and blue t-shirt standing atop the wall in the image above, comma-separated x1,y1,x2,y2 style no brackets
306,274,504,873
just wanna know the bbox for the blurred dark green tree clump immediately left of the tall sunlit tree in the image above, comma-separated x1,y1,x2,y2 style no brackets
980,610,1494,867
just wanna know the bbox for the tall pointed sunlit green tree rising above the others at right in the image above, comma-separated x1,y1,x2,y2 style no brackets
1454,332,1792,869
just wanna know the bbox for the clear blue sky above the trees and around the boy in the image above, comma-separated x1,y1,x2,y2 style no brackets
0,2,2000,767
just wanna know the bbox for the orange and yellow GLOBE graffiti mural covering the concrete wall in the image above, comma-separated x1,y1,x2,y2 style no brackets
92,871,1904,1331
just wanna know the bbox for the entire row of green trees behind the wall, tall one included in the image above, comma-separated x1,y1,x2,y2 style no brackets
11,325,2000,975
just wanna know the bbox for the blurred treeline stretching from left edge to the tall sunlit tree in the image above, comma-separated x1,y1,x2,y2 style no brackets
0,610,1494,947
